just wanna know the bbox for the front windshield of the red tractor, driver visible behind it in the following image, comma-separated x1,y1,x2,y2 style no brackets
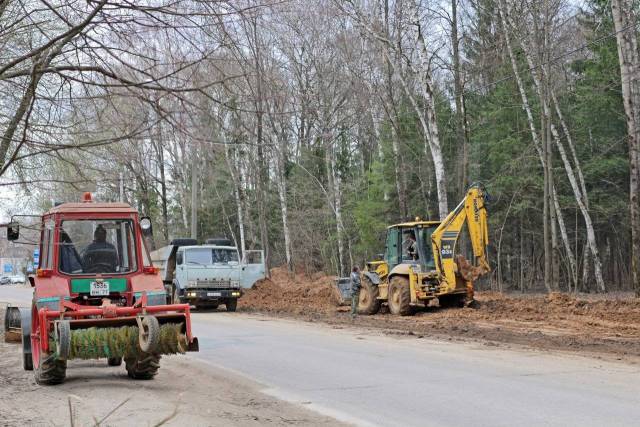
58,219,137,274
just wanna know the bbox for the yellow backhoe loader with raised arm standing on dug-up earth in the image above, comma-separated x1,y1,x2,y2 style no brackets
358,184,491,316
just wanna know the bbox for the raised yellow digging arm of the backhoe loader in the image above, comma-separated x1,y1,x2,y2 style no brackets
431,184,491,297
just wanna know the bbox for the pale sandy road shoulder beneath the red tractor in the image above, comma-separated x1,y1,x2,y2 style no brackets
0,306,343,427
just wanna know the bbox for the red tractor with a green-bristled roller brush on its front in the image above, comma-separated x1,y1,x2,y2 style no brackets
7,193,198,384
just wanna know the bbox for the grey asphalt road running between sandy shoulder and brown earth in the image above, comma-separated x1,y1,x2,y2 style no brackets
0,286,640,426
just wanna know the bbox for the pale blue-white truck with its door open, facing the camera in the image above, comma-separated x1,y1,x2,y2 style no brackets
151,239,265,311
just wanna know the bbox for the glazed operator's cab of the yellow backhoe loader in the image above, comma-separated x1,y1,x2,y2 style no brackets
384,221,440,271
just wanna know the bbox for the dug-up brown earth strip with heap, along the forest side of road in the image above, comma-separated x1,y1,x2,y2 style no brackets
239,268,640,362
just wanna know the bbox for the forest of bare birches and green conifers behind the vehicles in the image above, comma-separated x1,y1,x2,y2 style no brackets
0,0,640,292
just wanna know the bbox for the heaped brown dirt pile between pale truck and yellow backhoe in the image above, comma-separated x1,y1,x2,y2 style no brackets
238,267,339,314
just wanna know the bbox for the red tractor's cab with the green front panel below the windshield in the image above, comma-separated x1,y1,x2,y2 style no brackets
35,196,161,308
